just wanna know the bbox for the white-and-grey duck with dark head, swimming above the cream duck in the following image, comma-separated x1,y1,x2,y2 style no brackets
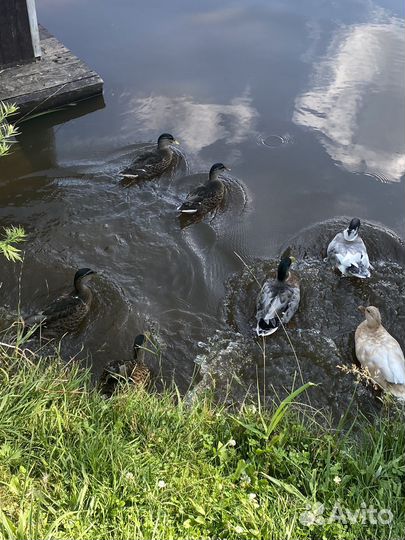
327,218,370,279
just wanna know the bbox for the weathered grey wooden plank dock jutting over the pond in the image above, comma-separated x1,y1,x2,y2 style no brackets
0,26,103,116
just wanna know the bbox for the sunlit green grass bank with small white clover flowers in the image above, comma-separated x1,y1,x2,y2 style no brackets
0,349,405,540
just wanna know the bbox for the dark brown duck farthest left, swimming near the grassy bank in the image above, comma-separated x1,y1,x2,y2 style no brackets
24,268,96,336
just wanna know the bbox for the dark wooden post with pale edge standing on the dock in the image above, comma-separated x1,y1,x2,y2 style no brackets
0,0,41,66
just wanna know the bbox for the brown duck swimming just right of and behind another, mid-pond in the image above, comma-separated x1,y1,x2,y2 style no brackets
177,163,230,214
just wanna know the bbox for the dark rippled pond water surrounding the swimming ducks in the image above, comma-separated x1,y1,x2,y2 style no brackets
0,0,405,410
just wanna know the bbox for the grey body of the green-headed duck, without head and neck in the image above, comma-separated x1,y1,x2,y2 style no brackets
256,281,300,336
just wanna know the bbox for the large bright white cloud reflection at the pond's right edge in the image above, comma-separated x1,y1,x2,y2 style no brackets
293,18,405,182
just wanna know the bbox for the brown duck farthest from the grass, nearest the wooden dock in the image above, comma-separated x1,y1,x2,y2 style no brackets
121,133,179,180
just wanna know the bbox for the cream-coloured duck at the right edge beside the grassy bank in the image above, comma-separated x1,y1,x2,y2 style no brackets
354,306,405,400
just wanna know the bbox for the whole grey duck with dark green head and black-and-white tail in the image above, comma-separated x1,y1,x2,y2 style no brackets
256,257,300,336
